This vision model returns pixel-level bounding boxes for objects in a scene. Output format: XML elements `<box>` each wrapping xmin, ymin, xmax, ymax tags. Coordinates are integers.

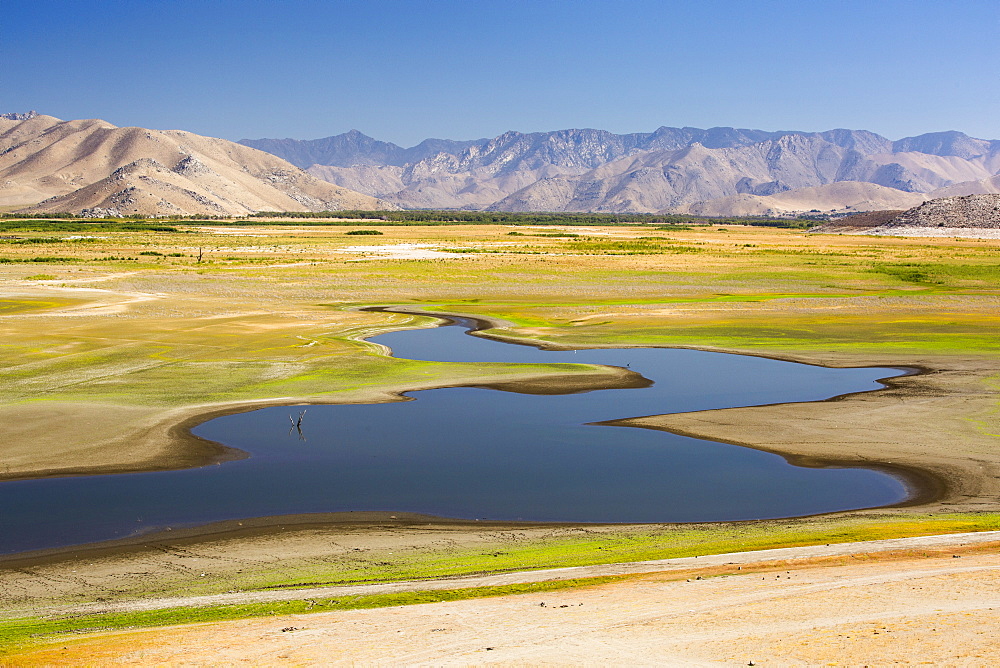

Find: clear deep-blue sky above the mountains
<box><xmin>0</xmin><ymin>0</ymin><xmax>1000</xmax><ymax>146</ymax></box>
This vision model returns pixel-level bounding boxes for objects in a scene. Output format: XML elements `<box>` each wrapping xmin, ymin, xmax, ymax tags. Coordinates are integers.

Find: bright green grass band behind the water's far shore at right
<box><xmin>434</xmin><ymin>298</ymin><xmax>1000</xmax><ymax>355</ymax></box>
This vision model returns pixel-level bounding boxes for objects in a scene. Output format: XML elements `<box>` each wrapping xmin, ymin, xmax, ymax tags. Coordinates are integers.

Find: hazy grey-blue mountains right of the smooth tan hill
<box><xmin>240</xmin><ymin>127</ymin><xmax>1000</xmax><ymax>216</ymax></box>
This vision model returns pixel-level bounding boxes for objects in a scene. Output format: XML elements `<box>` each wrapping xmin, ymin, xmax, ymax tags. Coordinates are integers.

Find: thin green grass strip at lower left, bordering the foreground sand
<box><xmin>0</xmin><ymin>576</ymin><xmax>616</xmax><ymax>656</ymax></box>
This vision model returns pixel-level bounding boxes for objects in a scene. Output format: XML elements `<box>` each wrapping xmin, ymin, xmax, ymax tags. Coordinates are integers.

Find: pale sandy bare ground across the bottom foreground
<box><xmin>7</xmin><ymin>536</ymin><xmax>1000</xmax><ymax>666</ymax></box>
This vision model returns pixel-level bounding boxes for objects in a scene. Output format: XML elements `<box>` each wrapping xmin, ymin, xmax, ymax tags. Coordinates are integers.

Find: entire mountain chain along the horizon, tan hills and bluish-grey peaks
<box><xmin>0</xmin><ymin>112</ymin><xmax>1000</xmax><ymax>216</ymax></box>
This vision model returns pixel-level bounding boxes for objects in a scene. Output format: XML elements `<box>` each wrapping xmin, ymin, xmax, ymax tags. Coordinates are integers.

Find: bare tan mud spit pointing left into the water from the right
<box><xmin>621</xmin><ymin>357</ymin><xmax>1000</xmax><ymax>512</ymax></box>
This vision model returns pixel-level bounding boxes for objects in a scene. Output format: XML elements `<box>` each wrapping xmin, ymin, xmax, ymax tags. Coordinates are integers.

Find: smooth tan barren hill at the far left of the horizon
<box><xmin>0</xmin><ymin>115</ymin><xmax>394</xmax><ymax>216</ymax></box>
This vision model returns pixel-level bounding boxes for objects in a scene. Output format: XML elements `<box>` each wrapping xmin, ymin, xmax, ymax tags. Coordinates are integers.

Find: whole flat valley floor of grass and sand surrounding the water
<box><xmin>0</xmin><ymin>220</ymin><xmax>1000</xmax><ymax>665</ymax></box>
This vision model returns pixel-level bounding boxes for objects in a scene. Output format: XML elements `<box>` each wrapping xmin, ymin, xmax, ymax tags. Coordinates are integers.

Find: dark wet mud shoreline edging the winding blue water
<box><xmin>0</xmin><ymin>307</ymin><xmax>984</xmax><ymax>564</ymax></box>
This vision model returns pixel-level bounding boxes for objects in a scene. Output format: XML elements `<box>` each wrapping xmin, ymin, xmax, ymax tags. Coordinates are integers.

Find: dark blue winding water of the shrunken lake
<box><xmin>0</xmin><ymin>319</ymin><xmax>908</xmax><ymax>553</ymax></box>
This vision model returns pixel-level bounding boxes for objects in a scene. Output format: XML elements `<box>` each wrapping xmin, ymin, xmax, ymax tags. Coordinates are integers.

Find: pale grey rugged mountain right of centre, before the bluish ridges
<box><xmin>490</xmin><ymin>135</ymin><xmax>960</xmax><ymax>215</ymax></box>
